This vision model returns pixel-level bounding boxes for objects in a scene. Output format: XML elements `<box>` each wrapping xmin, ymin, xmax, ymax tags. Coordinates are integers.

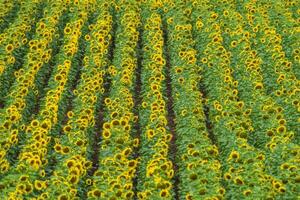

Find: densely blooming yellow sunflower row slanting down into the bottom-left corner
<box><xmin>0</xmin><ymin>1</ymin><xmax>94</xmax><ymax>198</ymax></box>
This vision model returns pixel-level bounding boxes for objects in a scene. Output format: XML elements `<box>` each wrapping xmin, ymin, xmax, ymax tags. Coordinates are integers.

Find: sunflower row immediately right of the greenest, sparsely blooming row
<box><xmin>191</xmin><ymin>1</ymin><xmax>288</xmax><ymax>198</ymax></box>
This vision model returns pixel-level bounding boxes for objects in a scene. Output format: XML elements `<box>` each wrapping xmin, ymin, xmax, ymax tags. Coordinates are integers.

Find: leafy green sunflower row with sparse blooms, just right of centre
<box><xmin>166</xmin><ymin>1</ymin><xmax>225</xmax><ymax>199</ymax></box>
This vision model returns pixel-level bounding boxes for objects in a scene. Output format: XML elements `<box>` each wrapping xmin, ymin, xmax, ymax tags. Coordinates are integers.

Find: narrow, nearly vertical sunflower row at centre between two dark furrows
<box><xmin>137</xmin><ymin>7</ymin><xmax>174</xmax><ymax>199</ymax></box>
